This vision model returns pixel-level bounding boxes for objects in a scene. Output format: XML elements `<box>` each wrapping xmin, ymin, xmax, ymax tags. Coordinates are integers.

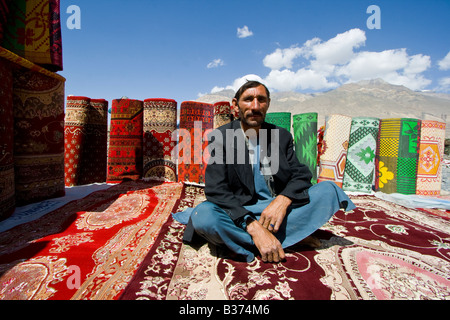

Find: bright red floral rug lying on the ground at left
<box><xmin>0</xmin><ymin>181</ymin><xmax>183</xmax><ymax>300</ymax></box>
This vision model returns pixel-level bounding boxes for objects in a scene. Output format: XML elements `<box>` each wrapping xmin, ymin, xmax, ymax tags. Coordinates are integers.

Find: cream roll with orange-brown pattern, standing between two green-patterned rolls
<box><xmin>317</xmin><ymin>114</ymin><xmax>352</xmax><ymax>188</ymax></box>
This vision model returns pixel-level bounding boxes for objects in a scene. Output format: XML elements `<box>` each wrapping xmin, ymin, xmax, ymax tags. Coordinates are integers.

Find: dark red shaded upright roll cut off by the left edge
<box><xmin>0</xmin><ymin>58</ymin><xmax>15</xmax><ymax>220</ymax></box>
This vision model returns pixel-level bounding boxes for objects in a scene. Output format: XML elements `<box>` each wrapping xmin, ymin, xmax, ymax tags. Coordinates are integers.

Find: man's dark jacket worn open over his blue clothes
<box><xmin>184</xmin><ymin>120</ymin><xmax>312</xmax><ymax>242</ymax></box>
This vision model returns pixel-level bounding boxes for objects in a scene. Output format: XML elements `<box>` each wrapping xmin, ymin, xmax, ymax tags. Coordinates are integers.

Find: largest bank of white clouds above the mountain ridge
<box><xmin>213</xmin><ymin>29</ymin><xmax>434</xmax><ymax>91</ymax></box>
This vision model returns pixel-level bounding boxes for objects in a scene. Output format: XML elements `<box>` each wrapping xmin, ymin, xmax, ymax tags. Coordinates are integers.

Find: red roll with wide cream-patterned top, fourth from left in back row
<box><xmin>143</xmin><ymin>99</ymin><xmax>177</xmax><ymax>181</ymax></box>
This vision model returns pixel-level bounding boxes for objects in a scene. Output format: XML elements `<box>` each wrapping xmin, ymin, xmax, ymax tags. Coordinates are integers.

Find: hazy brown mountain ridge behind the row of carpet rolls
<box><xmin>197</xmin><ymin>79</ymin><xmax>450</xmax><ymax>138</ymax></box>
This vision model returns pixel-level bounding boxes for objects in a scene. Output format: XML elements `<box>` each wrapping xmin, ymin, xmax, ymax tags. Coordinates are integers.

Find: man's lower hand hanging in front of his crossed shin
<box><xmin>247</xmin><ymin>220</ymin><xmax>285</xmax><ymax>262</ymax></box>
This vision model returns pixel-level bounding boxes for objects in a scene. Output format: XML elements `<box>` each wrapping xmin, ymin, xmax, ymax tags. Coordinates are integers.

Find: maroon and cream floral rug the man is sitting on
<box><xmin>120</xmin><ymin>186</ymin><xmax>450</xmax><ymax>300</ymax></box>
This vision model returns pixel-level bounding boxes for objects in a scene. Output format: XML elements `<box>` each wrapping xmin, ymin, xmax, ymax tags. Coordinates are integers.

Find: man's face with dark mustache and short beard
<box><xmin>233</xmin><ymin>86</ymin><xmax>270</xmax><ymax>129</ymax></box>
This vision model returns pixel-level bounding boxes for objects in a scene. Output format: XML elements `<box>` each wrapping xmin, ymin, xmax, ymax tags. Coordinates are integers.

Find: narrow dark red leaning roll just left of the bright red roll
<box><xmin>78</xmin><ymin>99</ymin><xmax>108</xmax><ymax>185</ymax></box>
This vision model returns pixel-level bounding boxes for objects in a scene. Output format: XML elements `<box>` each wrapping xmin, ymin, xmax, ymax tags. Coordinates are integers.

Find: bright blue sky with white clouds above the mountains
<box><xmin>61</xmin><ymin>0</ymin><xmax>450</xmax><ymax>104</ymax></box>
